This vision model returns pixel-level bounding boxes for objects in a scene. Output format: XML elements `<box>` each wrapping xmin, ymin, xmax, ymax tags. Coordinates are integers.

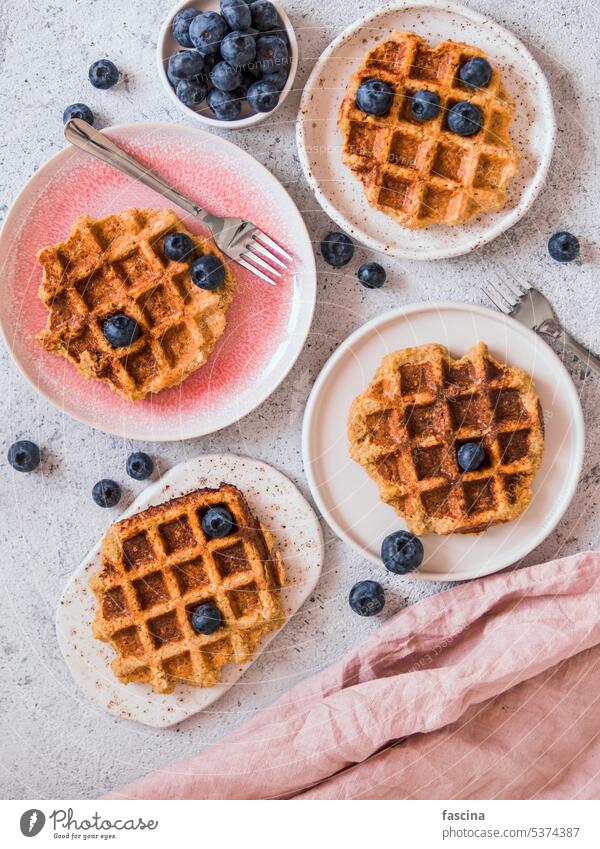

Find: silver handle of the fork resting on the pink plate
<box><xmin>65</xmin><ymin>118</ymin><xmax>213</xmax><ymax>226</ymax></box>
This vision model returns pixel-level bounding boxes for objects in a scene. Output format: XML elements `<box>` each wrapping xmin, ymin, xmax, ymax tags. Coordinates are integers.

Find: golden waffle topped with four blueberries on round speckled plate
<box><xmin>338</xmin><ymin>32</ymin><xmax>519</xmax><ymax>229</ymax></box>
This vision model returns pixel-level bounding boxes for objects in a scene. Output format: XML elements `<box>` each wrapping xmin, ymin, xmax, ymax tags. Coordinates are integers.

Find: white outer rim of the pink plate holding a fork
<box><xmin>0</xmin><ymin>121</ymin><xmax>317</xmax><ymax>442</ymax></box>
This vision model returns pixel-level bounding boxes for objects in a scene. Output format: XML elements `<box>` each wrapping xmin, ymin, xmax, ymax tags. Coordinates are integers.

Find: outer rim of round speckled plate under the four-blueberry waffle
<box><xmin>296</xmin><ymin>0</ymin><xmax>557</xmax><ymax>260</ymax></box>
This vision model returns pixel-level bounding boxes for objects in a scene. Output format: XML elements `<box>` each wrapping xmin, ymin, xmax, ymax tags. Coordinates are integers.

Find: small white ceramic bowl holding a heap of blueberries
<box><xmin>156</xmin><ymin>0</ymin><xmax>298</xmax><ymax>130</ymax></box>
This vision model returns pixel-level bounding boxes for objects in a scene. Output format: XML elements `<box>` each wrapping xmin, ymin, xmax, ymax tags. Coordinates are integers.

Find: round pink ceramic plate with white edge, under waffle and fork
<box><xmin>0</xmin><ymin>124</ymin><xmax>316</xmax><ymax>441</ymax></box>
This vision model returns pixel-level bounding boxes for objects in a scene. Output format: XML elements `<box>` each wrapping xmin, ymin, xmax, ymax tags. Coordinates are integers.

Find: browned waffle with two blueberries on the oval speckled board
<box><xmin>90</xmin><ymin>483</ymin><xmax>285</xmax><ymax>693</ymax></box>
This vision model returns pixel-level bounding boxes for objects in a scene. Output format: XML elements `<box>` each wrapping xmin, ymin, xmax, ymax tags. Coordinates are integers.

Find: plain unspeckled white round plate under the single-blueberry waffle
<box><xmin>302</xmin><ymin>303</ymin><xmax>584</xmax><ymax>581</ymax></box>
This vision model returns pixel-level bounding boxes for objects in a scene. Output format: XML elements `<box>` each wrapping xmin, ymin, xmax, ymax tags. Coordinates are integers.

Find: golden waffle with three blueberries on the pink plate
<box><xmin>38</xmin><ymin>209</ymin><xmax>235</xmax><ymax>401</ymax></box>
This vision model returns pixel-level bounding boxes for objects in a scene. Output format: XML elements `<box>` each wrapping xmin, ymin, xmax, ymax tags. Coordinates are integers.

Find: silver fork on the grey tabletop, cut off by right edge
<box><xmin>481</xmin><ymin>263</ymin><xmax>600</xmax><ymax>376</ymax></box>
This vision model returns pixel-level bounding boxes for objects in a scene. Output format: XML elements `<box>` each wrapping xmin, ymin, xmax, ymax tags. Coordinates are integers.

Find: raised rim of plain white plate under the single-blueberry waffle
<box><xmin>302</xmin><ymin>301</ymin><xmax>585</xmax><ymax>583</ymax></box>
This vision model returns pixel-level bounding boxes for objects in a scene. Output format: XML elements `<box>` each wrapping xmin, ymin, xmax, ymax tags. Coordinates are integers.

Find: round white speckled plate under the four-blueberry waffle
<box><xmin>297</xmin><ymin>0</ymin><xmax>556</xmax><ymax>260</ymax></box>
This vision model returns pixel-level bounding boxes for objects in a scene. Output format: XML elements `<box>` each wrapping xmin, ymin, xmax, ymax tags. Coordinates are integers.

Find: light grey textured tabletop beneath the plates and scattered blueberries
<box><xmin>0</xmin><ymin>0</ymin><xmax>600</xmax><ymax>798</ymax></box>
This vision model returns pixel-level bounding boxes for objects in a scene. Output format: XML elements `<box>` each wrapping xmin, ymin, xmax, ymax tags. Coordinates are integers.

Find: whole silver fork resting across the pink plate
<box><xmin>65</xmin><ymin>118</ymin><xmax>293</xmax><ymax>286</ymax></box>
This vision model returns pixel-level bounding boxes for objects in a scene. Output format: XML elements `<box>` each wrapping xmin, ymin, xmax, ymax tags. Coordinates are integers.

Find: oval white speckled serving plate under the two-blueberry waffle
<box><xmin>56</xmin><ymin>454</ymin><xmax>323</xmax><ymax>728</ymax></box>
